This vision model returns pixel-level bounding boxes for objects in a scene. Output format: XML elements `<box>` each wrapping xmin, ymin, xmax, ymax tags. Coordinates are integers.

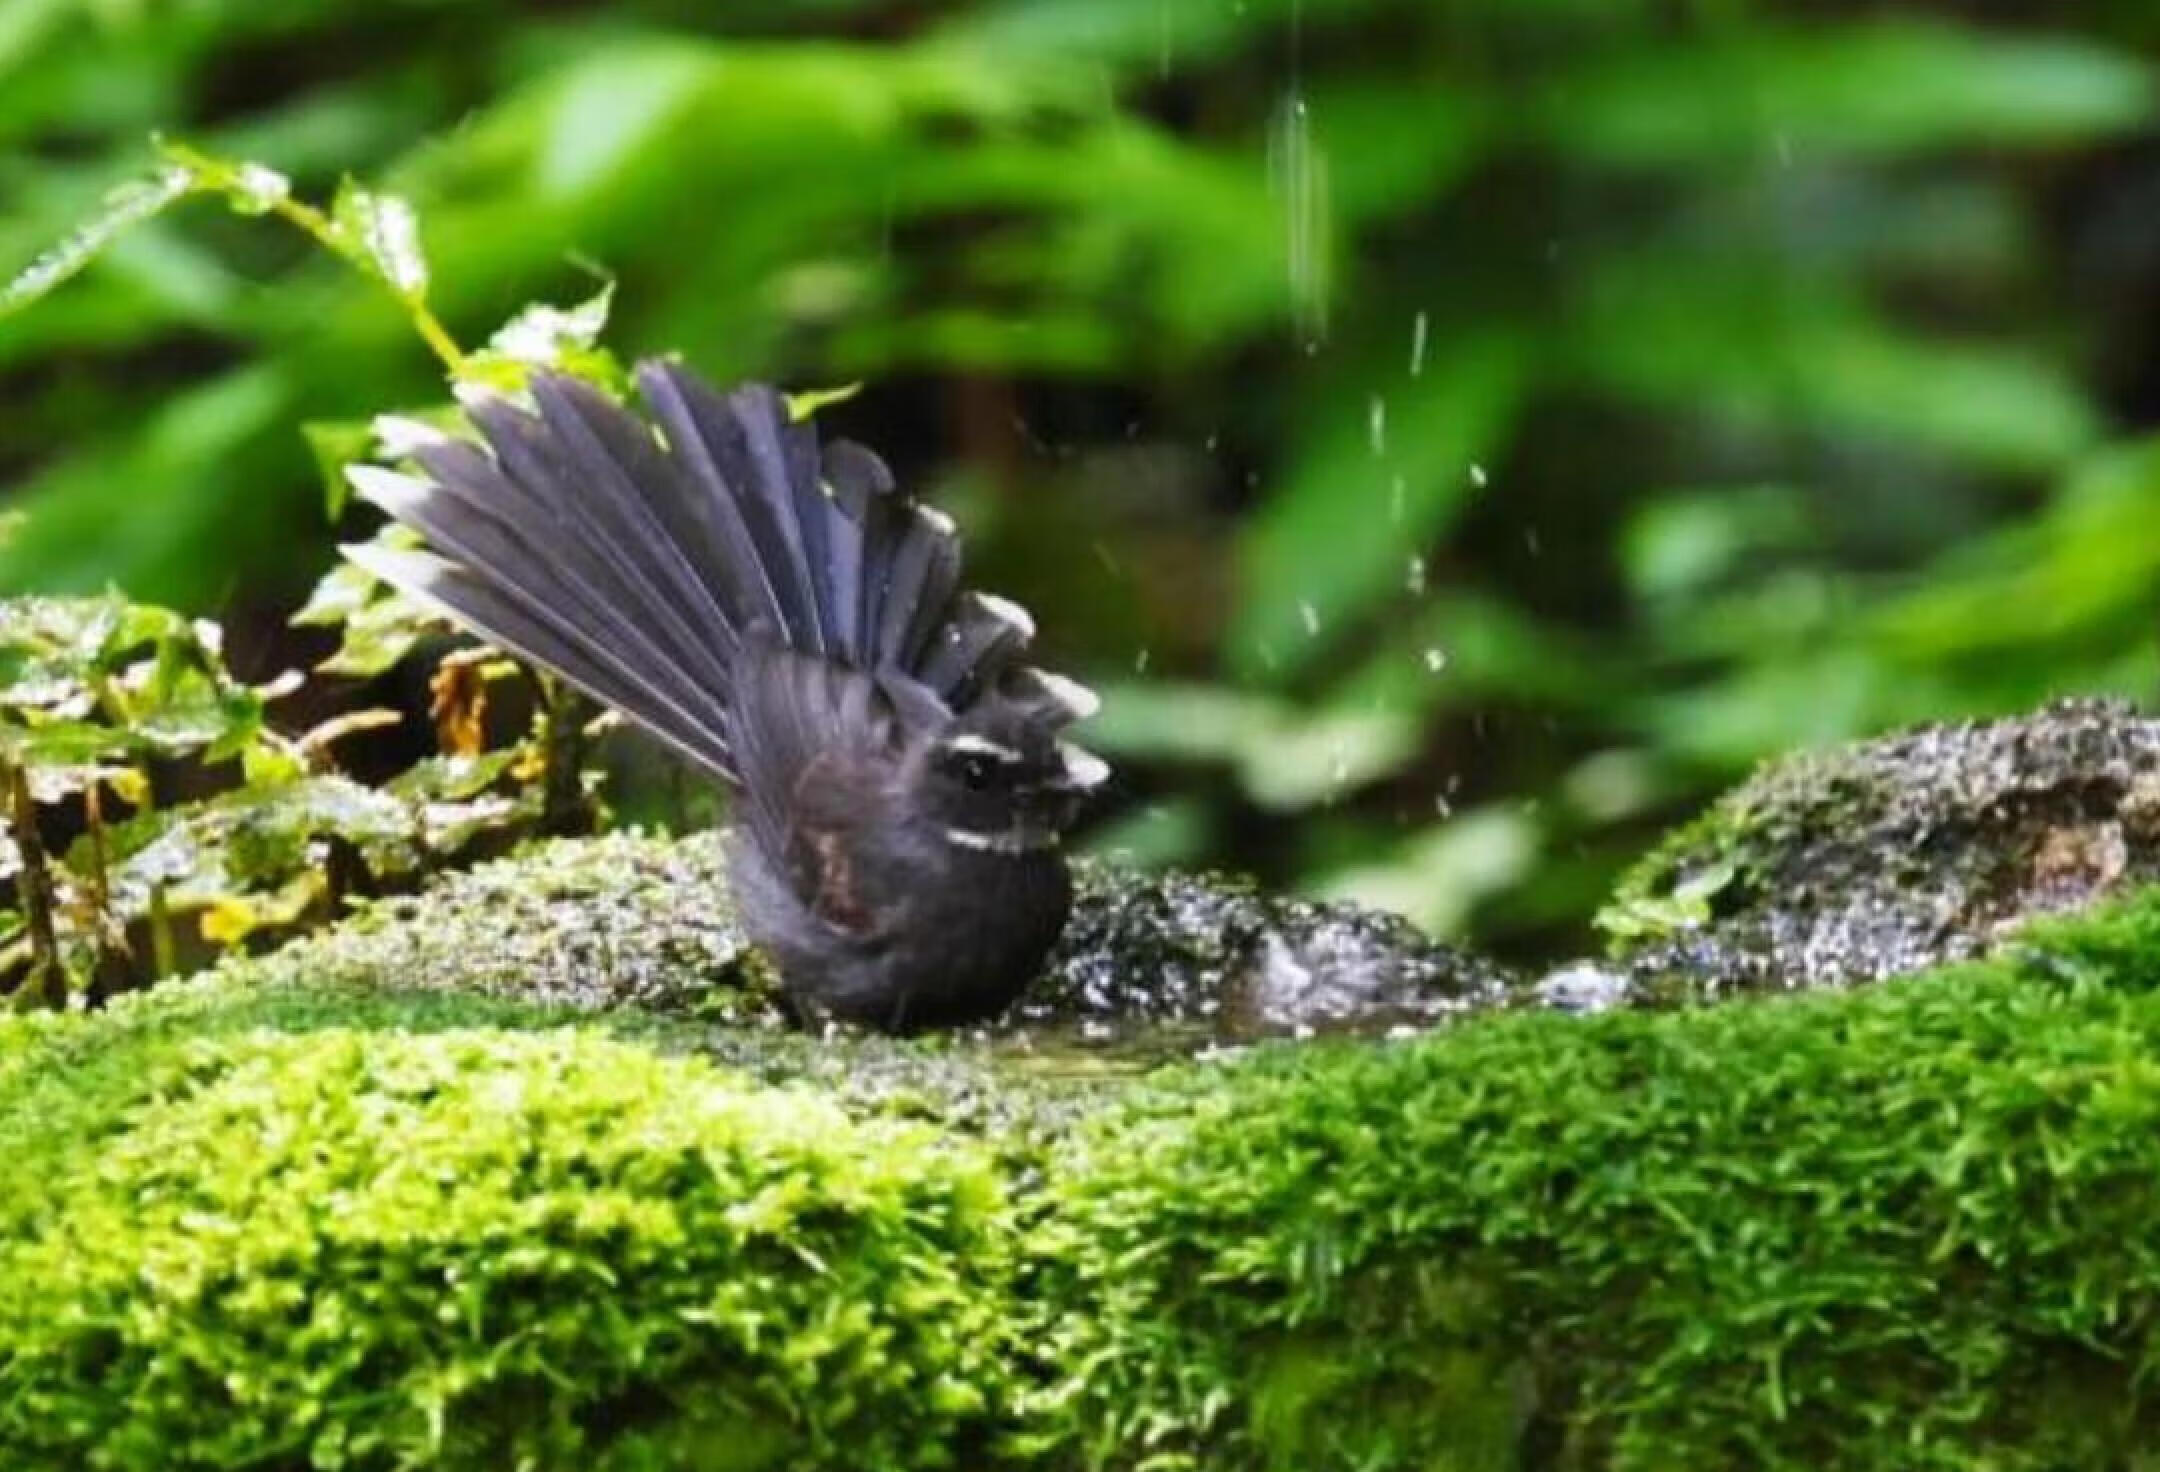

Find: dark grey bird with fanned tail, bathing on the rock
<box><xmin>341</xmin><ymin>359</ymin><xmax>1110</xmax><ymax>1033</ymax></box>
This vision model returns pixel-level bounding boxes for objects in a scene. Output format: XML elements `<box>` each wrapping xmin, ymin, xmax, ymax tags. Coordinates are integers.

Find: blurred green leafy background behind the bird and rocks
<box><xmin>0</xmin><ymin>0</ymin><xmax>2160</xmax><ymax>953</ymax></box>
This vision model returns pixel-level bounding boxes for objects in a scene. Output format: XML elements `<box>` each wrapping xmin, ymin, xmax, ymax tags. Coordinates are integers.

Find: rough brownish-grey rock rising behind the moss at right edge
<box><xmin>1598</xmin><ymin>700</ymin><xmax>2160</xmax><ymax>1005</ymax></box>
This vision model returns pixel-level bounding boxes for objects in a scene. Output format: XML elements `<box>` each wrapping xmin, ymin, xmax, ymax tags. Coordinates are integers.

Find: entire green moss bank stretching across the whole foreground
<box><xmin>12</xmin><ymin>891</ymin><xmax>2160</xmax><ymax>1472</ymax></box>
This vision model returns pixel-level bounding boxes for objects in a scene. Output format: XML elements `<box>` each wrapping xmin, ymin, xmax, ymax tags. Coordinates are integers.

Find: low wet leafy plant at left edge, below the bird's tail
<box><xmin>0</xmin><ymin>579</ymin><xmax>542</xmax><ymax>1003</ymax></box>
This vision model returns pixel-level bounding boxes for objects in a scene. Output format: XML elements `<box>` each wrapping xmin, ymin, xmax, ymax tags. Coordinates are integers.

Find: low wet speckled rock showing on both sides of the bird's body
<box><xmin>298</xmin><ymin>832</ymin><xmax>1510</xmax><ymax>1046</ymax></box>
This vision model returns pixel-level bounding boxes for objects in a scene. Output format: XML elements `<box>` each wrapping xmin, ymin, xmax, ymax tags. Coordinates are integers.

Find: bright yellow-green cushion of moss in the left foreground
<box><xmin>0</xmin><ymin>1002</ymin><xmax>1002</xmax><ymax>1470</ymax></box>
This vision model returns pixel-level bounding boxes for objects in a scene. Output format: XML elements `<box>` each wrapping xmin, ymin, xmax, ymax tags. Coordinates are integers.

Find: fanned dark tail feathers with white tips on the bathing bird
<box><xmin>348</xmin><ymin>361</ymin><xmax>1084</xmax><ymax>782</ymax></box>
